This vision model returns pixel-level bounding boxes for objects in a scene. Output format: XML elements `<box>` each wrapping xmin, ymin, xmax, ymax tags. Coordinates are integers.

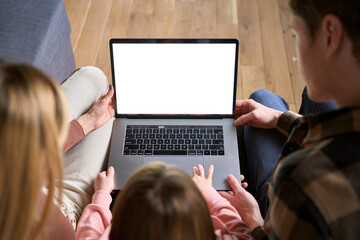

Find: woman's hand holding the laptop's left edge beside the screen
<box><xmin>76</xmin><ymin>85</ymin><xmax>115</xmax><ymax>135</ymax></box>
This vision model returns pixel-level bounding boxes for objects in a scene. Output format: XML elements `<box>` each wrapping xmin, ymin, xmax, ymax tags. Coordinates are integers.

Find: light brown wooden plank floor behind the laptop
<box><xmin>64</xmin><ymin>0</ymin><xmax>304</xmax><ymax>111</ymax></box>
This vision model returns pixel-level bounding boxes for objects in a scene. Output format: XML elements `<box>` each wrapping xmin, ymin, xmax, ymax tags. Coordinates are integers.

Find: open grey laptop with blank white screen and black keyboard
<box><xmin>108</xmin><ymin>39</ymin><xmax>240</xmax><ymax>190</ymax></box>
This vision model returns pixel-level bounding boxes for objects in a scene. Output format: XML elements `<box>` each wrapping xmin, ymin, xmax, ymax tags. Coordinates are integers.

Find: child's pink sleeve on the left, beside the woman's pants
<box><xmin>76</xmin><ymin>190</ymin><xmax>112</xmax><ymax>239</ymax></box>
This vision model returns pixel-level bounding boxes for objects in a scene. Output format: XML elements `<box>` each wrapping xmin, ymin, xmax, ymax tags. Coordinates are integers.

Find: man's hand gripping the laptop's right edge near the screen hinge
<box><xmin>235</xmin><ymin>99</ymin><xmax>283</xmax><ymax>129</ymax></box>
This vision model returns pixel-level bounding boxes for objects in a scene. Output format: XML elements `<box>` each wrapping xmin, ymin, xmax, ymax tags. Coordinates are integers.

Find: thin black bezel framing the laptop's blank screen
<box><xmin>109</xmin><ymin>38</ymin><xmax>239</xmax><ymax>119</ymax></box>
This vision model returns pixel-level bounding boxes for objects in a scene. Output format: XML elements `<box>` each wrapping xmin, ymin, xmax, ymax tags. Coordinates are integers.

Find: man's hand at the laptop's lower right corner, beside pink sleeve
<box><xmin>219</xmin><ymin>175</ymin><xmax>264</xmax><ymax>231</ymax></box>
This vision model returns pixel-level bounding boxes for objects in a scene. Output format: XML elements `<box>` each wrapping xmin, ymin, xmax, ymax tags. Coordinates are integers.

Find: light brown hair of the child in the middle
<box><xmin>110</xmin><ymin>162</ymin><xmax>215</xmax><ymax>240</ymax></box>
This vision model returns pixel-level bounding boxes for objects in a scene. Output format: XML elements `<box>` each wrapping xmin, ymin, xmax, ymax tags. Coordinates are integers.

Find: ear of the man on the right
<box><xmin>322</xmin><ymin>14</ymin><xmax>345</xmax><ymax>58</ymax></box>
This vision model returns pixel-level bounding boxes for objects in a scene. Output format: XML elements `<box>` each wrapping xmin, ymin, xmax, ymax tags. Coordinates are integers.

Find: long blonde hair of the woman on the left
<box><xmin>0</xmin><ymin>62</ymin><xmax>68</xmax><ymax>240</ymax></box>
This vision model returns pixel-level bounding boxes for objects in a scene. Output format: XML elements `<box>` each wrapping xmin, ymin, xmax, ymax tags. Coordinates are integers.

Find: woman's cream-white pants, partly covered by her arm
<box><xmin>60</xmin><ymin>67</ymin><xmax>114</xmax><ymax>228</ymax></box>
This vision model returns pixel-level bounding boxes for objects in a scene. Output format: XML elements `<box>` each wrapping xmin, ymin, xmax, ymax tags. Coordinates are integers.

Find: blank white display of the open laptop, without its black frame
<box><xmin>112</xmin><ymin>43</ymin><xmax>237</xmax><ymax>115</ymax></box>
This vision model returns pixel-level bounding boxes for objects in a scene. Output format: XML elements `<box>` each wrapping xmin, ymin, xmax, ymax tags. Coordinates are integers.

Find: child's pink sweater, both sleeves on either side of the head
<box><xmin>76</xmin><ymin>188</ymin><xmax>253</xmax><ymax>240</ymax></box>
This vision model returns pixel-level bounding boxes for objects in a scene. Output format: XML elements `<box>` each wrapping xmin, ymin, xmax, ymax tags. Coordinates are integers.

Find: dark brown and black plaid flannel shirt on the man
<box><xmin>253</xmin><ymin>107</ymin><xmax>360</xmax><ymax>239</ymax></box>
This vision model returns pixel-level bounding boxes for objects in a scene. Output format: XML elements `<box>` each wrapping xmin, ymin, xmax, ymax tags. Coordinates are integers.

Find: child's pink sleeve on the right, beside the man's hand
<box><xmin>203</xmin><ymin>188</ymin><xmax>253</xmax><ymax>239</ymax></box>
